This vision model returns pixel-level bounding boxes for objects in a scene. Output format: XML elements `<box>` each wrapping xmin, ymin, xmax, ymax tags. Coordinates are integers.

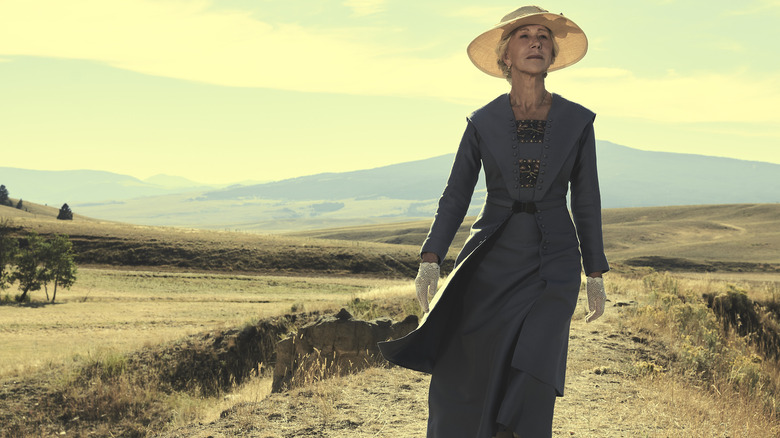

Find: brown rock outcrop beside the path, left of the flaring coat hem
<box><xmin>272</xmin><ymin>309</ymin><xmax>418</xmax><ymax>392</ymax></box>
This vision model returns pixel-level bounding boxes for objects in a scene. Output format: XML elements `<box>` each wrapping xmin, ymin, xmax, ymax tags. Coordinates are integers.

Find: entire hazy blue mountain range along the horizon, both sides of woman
<box><xmin>0</xmin><ymin>141</ymin><xmax>780</xmax><ymax>232</ymax></box>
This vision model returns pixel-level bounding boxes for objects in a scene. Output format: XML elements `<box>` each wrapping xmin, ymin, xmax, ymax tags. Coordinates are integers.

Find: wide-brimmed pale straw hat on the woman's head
<box><xmin>466</xmin><ymin>6</ymin><xmax>588</xmax><ymax>78</ymax></box>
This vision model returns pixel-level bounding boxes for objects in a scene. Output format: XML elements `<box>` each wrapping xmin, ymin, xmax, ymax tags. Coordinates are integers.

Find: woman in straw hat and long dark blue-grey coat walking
<box><xmin>380</xmin><ymin>6</ymin><xmax>609</xmax><ymax>438</ymax></box>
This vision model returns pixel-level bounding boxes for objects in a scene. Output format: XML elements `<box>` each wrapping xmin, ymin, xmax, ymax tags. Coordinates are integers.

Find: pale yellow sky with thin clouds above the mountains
<box><xmin>0</xmin><ymin>0</ymin><xmax>780</xmax><ymax>183</ymax></box>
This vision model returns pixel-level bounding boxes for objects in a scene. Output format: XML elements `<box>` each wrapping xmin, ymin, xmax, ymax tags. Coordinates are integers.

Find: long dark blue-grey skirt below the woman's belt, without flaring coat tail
<box><xmin>428</xmin><ymin>213</ymin><xmax>557</xmax><ymax>438</ymax></box>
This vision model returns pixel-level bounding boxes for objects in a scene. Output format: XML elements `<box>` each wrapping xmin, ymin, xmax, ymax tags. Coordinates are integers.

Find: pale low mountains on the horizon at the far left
<box><xmin>0</xmin><ymin>167</ymin><xmax>216</xmax><ymax>206</ymax></box>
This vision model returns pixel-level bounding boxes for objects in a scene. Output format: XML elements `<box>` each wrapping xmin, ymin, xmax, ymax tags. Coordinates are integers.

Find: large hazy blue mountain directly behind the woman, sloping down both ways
<box><xmin>198</xmin><ymin>141</ymin><xmax>780</xmax><ymax>208</ymax></box>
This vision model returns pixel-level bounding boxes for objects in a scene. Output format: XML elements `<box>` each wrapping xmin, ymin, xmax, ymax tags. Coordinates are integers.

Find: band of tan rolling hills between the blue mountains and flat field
<box><xmin>0</xmin><ymin>200</ymin><xmax>780</xmax><ymax>277</ymax></box>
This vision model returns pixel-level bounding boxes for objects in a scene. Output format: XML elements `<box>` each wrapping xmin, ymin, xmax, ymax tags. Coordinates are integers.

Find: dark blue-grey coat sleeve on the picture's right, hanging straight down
<box><xmin>571</xmin><ymin>123</ymin><xmax>609</xmax><ymax>274</ymax></box>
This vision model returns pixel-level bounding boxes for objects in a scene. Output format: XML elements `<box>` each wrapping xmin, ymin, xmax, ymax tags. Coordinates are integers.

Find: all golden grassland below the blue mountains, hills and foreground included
<box><xmin>0</xmin><ymin>204</ymin><xmax>780</xmax><ymax>438</ymax></box>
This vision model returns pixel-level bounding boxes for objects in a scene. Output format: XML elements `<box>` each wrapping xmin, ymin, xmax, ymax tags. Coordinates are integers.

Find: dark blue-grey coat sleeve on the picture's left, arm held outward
<box><xmin>421</xmin><ymin>121</ymin><xmax>482</xmax><ymax>261</ymax></box>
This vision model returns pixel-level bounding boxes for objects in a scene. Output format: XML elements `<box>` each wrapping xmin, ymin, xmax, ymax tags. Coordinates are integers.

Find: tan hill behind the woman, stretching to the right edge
<box><xmin>289</xmin><ymin>204</ymin><xmax>780</xmax><ymax>271</ymax></box>
